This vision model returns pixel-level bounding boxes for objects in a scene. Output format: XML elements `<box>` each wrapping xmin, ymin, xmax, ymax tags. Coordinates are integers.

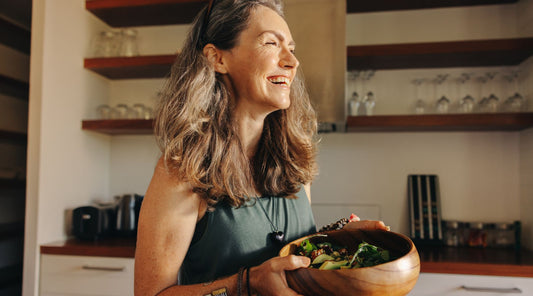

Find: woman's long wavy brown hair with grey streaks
<box><xmin>154</xmin><ymin>0</ymin><xmax>317</xmax><ymax>208</ymax></box>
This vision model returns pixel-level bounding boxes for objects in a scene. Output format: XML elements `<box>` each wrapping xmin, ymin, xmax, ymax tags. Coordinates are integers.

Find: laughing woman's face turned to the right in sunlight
<box><xmin>218</xmin><ymin>6</ymin><xmax>299</xmax><ymax>116</ymax></box>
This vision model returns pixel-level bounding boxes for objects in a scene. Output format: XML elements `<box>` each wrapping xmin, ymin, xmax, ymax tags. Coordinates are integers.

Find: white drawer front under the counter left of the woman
<box><xmin>40</xmin><ymin>254</ymin><xmax>134</xmax><ymax>296</ymax></box>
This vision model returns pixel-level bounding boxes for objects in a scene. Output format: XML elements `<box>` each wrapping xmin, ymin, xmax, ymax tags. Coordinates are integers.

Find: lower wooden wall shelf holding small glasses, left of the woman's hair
<box><xmin>81</xmin><ymin>119</ymin><xmax>154</xmax><ymax>135</ymax></box>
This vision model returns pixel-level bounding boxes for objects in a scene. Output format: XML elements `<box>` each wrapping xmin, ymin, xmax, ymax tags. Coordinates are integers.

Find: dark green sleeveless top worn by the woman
<box><xmin>179</xmin><ymin>186</ymin><xmax>316</xmax><ymax>285</ymax></box>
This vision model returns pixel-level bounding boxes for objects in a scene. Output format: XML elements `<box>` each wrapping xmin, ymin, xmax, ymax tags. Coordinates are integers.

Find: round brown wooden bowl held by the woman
<box><xmin>279</xmin><ymin>229</ymin><xmax>420</xmax><ymax>296</ymax></box>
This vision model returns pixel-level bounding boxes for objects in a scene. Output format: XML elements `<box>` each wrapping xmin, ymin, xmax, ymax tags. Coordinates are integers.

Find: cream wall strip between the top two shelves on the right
<box><xmin>346</xmin><ymin>4</ymin><xmax>518</xmax><ymax>45</ymax></box>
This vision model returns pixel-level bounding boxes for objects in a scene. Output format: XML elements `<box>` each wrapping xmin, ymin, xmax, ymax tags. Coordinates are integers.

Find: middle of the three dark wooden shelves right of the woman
<box><xmin>347</xmin><ymin>38</ymin><xmax>533</xmax><ymax>70</ymax></box>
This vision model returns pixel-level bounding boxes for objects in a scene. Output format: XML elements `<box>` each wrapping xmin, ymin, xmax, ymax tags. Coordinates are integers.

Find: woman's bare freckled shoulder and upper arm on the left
<box><xmin>135</xmin><ymin>160</ymin><xmax>202</xmax><ymax>295</ymax></box>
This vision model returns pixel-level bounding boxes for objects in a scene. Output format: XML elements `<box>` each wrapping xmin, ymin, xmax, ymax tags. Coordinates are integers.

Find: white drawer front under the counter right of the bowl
<box><xmin>409</xmin><ymin>273</ymin><xmax>533</xmax><ymax>296</ymax></box>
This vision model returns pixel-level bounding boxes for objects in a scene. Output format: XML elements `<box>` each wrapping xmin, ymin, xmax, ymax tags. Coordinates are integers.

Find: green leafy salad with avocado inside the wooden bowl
<box><xmin>295</xmin><ymin>234</ymin><xmax>393</xmax><ymax>270</ymax></box>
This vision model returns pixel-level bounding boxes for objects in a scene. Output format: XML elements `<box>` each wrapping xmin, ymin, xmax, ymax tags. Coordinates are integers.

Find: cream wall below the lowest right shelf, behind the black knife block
<box><xmin>312</xmin><ymin>132</ymin><xmax>520</xmax><ymax>234</ymax></box>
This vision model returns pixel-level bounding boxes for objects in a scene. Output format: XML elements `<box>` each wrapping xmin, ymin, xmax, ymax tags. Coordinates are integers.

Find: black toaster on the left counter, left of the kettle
<box><xmin>72</xmin><ymin>205</ymin><xmax>116</xmax><ymax>240</ymax></box>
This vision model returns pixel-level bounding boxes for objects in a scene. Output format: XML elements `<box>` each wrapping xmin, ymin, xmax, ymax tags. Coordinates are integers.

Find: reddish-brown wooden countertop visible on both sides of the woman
<box><xmin>41</xmin><ymin>238</ymin><xmax>533</xmax><ymax>277</ymax></box>
